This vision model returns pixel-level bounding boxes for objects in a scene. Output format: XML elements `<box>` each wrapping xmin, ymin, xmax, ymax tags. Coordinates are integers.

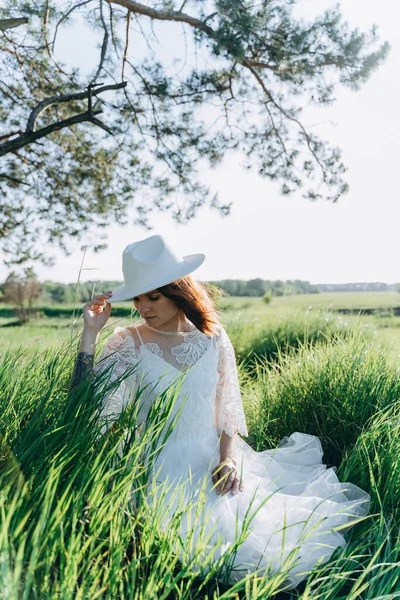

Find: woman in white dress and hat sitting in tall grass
<box><xmin>73</xmin><ymin>236</ymin><xmax>369</xmax><ymax>588</ymax></box>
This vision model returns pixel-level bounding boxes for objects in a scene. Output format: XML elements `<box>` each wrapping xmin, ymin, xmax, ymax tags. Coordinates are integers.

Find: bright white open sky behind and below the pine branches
<box><xmin>0</xmin><ymin>0</ymin><xmax>400</xmax><ymax>283</ymax></box>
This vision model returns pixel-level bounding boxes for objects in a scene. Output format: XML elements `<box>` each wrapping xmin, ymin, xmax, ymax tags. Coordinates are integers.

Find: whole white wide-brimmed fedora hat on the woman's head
<box><xmin>108</xmin><ymin>235</ymin><xmax>205</xmax><ymax>302</ymax></box>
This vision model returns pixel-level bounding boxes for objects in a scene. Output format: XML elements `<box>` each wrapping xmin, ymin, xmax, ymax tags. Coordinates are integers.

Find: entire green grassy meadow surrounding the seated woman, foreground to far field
<box><xmin>0</xmin><ymin>293</ymin><xmax>400</xmax><ymax>600</ymax></box>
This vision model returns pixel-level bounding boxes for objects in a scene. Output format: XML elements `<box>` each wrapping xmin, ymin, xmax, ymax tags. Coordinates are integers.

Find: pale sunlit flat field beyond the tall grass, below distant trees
<box><xmin>0</xmin><ymin>292</ymin><xmax>400</xmax><ymax>350</ymax></box>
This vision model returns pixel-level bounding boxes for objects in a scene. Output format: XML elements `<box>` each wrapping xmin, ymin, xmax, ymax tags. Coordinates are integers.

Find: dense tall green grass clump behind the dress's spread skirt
<box><xmin>245</xmin><ymin>331</ymin><xmax>400</xmax><ymax>465</ymax></box>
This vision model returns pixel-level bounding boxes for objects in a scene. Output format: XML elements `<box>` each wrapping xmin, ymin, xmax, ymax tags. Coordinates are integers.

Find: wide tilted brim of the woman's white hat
<box><xmin>107</xmin><ymin>254</ymin><xmax>205</xmax><ymax>303</ymax></box>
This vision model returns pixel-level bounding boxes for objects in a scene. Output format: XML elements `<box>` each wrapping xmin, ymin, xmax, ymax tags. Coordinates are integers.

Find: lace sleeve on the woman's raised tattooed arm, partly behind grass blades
<box><xmin>93</xmin><ymin>327</ymin><xmax>138</xmax><ymax>433</ymax></box>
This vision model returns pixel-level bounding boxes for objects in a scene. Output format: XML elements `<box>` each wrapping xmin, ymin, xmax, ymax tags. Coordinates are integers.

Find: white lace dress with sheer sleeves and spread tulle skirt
<box><xmin>94</xmin><ymin>325</ymin><xmax>369</xmax><ymax>588</ymax></box>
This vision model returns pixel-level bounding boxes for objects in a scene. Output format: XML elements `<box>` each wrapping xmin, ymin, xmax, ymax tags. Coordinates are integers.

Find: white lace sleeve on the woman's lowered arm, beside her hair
<box><xmin>215</xmin><ymin>327</ymin><xmax>248</xmax><ymax>437</ymax></box>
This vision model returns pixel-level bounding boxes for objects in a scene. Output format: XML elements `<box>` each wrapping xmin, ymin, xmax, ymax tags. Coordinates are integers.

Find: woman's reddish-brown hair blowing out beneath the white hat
<box><xmin>153</xmin><ymin>275</ymin><xmax>224</xmax><ymax>335</ymax></box>
